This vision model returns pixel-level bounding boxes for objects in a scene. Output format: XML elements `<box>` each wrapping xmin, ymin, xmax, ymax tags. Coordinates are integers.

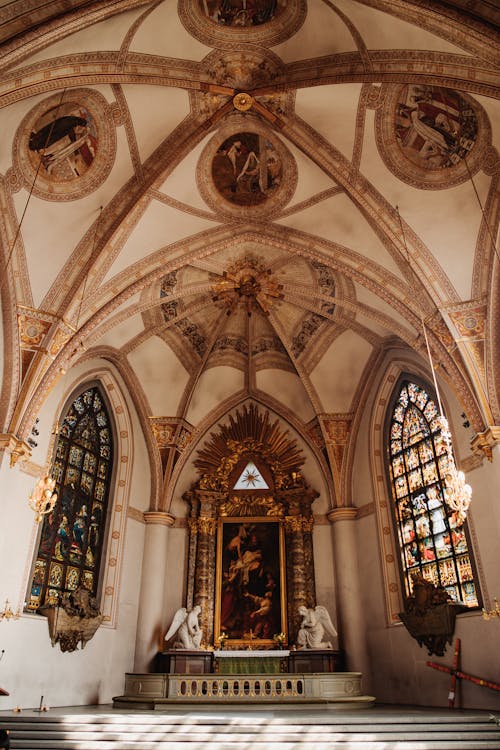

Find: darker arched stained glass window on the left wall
<box><xmin>27</xmin><ymin>386</ymin><xmax>113</xmax><ymax>610</ymax></box>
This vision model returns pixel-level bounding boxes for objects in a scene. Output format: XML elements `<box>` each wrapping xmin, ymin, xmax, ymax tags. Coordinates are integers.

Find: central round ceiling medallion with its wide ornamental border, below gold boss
<box><xmin>198</xmin><ymin>116</ymin><xmax>297</xmax><ymax>219</ymax></box>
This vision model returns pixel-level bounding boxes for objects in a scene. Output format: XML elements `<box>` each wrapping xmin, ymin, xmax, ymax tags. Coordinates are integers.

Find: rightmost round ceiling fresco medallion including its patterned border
<box><xmin>375</xmin><ymin>84</ymin><xmax>490</xmax><ymax>188</ymax></box>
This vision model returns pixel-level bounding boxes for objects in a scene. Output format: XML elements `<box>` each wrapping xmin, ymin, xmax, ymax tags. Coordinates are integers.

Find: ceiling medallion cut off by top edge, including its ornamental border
<box><xmin>179</xmin><ymin>0</ymin><xmax>307</xmax><ymax>48</ymax></box>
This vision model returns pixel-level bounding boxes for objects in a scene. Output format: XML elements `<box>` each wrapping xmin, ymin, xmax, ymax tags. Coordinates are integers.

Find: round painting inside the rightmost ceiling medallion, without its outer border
<box><xmin>395</xmin><ymin>84</ymin><xmax>478</xmax><ymax>170</ymax></box>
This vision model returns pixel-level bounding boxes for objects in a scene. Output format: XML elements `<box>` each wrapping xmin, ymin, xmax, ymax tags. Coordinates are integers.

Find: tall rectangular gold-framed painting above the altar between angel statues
<box><xmin>215</xmin><ymin>518</ymin><xmax>286</xmax><ymax>648</ymax></box>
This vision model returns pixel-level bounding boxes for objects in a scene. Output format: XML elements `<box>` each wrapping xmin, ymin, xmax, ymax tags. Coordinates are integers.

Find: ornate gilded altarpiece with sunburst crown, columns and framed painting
<box><xmin>183</xmin><ymin>404</ymin><xmax>318</xmax><ymax>648</ymax></box>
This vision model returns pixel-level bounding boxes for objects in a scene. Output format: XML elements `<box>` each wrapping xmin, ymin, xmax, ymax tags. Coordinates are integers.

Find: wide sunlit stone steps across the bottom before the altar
<box><xmin>0</xmin><ymin>706</ymin><xmax>500</xmax><ymax>750</ymax></box>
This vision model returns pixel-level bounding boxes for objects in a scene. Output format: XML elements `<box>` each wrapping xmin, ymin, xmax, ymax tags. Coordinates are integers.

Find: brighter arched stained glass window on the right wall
<box><xmin>389</xmin><ymin>381</ymin><xmax>479</xmax><ymax>607</ymax></box>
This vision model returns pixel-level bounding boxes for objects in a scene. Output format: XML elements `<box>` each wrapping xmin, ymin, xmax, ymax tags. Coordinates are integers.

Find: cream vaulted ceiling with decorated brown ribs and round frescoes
<box><xmin>0</xmin><ymin>0</ymin><xmax>500</xmax><ymax>506</ymax></box>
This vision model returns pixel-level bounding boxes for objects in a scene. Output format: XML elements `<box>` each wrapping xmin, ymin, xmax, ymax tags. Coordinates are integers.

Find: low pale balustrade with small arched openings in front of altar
<box><xmin>113</xmin><ymin>672</ymin><xmax>375</xmax><ymax>711</ymax></box>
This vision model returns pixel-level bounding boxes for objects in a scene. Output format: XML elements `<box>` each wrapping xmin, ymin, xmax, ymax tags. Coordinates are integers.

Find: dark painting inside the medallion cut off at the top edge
<box><xmin>199</xmin><ymin>0</ymin><xmax>287</xmax><ymax>28</ymax></box>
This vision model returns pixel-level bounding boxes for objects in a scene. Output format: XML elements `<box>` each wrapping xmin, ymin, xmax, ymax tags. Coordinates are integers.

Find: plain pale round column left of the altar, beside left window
<box><xmin>134</xmin><ymin>511</ymin><xmax>175</xmax><ymax>672</ymax></box>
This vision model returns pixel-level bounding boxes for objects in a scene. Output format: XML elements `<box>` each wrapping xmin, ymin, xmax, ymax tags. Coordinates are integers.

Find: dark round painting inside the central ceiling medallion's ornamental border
<box><xmin>212</xmin><ymin>132</ymin><xmax>283</xmax><ymax>206</ymax></box>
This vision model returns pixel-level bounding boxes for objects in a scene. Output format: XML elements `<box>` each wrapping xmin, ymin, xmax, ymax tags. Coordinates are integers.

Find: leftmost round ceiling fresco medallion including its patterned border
<box><xmin>14</xmin><ymin>89</ymin><xmax>116</xmax><ymax>200</ymax></box>
